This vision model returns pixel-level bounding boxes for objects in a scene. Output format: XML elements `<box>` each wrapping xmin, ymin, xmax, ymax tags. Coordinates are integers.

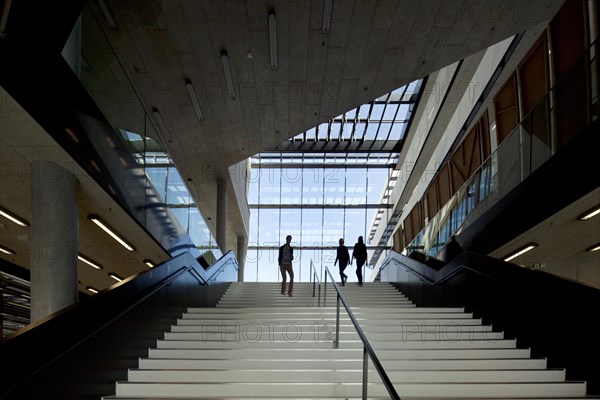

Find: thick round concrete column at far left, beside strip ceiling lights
<box><xmin>30</xmin><ymin>161</ymin><xmax>78</xmax><ymax>322</ymax></box>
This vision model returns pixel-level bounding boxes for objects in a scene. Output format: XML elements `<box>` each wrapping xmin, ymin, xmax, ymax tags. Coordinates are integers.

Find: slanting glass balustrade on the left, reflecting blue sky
<box><xmin>71</xmin><ymin>4</ymin><xmax>222</xmax><ymax>258</ymax></box>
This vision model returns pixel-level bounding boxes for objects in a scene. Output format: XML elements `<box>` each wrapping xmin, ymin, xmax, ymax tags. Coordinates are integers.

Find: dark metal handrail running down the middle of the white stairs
<box><xmin>319</xmin><ymin>267</ymin><xmax>400</xmax><ymax>400</ymax></box>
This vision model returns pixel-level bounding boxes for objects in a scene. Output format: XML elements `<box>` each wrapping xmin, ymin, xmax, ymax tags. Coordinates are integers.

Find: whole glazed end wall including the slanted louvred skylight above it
<box><xmin>244</xmin><ymin>80</ymin><xmax>423</xmax><ymax>282</ymax></box>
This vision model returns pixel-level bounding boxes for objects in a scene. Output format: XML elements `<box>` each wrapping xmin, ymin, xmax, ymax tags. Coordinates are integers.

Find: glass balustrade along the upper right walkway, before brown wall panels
<box><xmin>403</xmin><ymin>38</ymin><xmax>600</xmax><ymax>257</ymax></box>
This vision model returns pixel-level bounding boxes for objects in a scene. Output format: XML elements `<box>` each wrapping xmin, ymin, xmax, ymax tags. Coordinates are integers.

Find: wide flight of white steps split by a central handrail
<box><xmin>103</xmin><ymin>283</ymin><xmax>586</xmax><ymax>400</ymax></box>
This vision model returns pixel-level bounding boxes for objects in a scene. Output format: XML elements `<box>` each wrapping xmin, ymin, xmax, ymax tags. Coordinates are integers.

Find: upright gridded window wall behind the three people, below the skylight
<box><xmin>244</xmin><ymin>158</ymin><xmax>396</xmax><ymax>282</ymax></box>
